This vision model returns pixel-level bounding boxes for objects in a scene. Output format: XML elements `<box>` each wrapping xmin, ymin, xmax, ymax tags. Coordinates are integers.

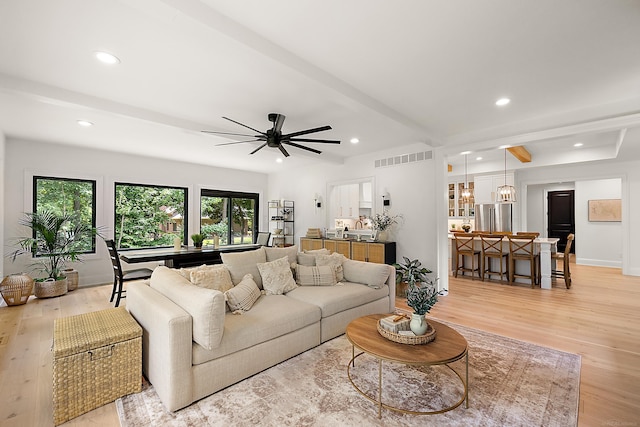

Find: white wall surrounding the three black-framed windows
<box><xmin>1</xmin><ymin>138</ymin><xmax>268</xmax><ymax>286</ymax></box>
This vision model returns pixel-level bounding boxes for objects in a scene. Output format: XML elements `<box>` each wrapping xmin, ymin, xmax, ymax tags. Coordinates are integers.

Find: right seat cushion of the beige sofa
<box><xmin>286</xmin><ymin>282</ymin><xmax>389</xmax><ymax>320</ymax></box>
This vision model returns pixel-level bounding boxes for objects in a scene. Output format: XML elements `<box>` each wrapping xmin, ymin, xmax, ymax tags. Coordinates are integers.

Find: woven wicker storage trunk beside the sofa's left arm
<box><xmin>52</xmin><ymin>307</ymin><xmax>142</xmax><ymax>425</ymax></box>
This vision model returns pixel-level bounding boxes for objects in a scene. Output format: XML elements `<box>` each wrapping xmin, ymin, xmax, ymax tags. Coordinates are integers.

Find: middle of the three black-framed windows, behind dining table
<box><xmin>113</xmin><ymin>182</ymin><xmax>188</xmax><ymax>249</ymax></box>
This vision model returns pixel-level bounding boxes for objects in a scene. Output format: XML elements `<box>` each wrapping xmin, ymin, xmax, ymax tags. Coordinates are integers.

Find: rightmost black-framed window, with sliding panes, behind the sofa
<box><xmin>200</xmin><ymin>190</ymin><xmax>259</xmax><ymax>245</ymax></box>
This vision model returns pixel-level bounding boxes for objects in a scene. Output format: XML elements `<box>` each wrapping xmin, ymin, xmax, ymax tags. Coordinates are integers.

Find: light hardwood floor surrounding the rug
<box><xmin>0</xmin><ymin>266</ymin><xmax>640</xmax><ymax>427</ymax></box>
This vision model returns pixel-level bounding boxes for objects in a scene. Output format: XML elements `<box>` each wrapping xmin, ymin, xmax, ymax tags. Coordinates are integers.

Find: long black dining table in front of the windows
<box><xmin>119</xmin><ymin>244</ymin><xmax>260</xmax><ymax>268</ymax></box>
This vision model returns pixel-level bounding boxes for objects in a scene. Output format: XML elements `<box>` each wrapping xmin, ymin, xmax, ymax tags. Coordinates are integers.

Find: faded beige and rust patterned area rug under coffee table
<box><xmin>116</xmin><ymin>325</ymin><xmax>580</xmax><ymax>427</ymax></box>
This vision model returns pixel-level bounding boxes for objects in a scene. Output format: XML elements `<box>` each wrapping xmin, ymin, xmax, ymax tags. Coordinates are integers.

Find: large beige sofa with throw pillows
<box><xmin>127</xmin><ymin>246</ymin><xmax>395</xmax><ymax>411</ymax></box>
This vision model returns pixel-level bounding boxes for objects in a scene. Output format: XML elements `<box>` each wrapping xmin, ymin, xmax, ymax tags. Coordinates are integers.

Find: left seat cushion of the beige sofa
<box><xmin>192</xmin><ymin>296</ymin><xmax>320</xmax><ymax>365</ymax></box>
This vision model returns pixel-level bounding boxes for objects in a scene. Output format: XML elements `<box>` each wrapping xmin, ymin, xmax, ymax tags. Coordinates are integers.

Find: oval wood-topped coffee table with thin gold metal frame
<box><xmin>347</xmin><ymin>314</ymin><xmax>469</xmax><ymax>418</ymax></box>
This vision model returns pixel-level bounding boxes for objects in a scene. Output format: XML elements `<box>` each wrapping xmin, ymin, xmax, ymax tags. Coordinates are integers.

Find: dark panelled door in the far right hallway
<box><xmin>547</xmin><ymin>190</ymin><xmax>576</xmax><ymax>253</ymax></box>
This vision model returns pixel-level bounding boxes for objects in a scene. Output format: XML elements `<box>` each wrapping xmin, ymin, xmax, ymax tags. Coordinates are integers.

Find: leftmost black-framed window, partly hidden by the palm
<box><xmin>33</xmin><ymin>176</ymin><xmax>96</xmax><ymax>253</ymax></box>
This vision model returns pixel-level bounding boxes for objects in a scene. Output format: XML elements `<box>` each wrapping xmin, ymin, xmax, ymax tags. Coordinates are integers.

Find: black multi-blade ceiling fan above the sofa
<box><xmin>202</xmin><ymin>113</ymin><xmax>340</xmax><ymax>157</ymax></box>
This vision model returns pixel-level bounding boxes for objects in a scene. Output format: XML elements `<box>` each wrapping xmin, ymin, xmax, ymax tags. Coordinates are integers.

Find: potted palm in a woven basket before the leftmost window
<box><xmin>10</xmin><ymin>210</ymin><xmax>97</xmax><ymax>298</ymax></box>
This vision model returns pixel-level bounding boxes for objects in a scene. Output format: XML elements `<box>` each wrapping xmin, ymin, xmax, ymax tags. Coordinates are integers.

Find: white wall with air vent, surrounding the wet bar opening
<box><xmin>268</xmin><ymin>144</ymin><xmax>447</xmax><ymax>276</ymax></box>
